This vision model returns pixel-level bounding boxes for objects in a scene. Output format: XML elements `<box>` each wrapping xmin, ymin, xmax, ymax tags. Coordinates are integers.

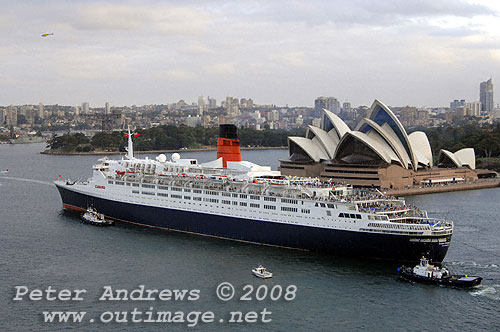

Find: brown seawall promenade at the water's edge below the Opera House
<box><xmin>384</xmin><ymin>178</ymin><xmax>500</xmax><ymax>197</ymax></box>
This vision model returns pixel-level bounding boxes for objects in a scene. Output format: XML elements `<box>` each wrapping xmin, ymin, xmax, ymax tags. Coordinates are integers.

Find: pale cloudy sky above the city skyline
<box><xmin>0</xmin><ymin>0</ymin><xmax>500</xmax><ymax>107</ymax></box>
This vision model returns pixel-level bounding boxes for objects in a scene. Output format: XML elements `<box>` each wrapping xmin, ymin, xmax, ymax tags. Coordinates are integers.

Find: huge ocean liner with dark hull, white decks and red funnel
<box><xmin>55</xmin><ymin>125</ymin><xmax>453</xmax><ymax>263</ymax></box>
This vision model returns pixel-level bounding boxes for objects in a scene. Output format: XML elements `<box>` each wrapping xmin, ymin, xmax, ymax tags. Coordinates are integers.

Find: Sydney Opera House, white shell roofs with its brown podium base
<box><xmin>280</xmin><ymin>100</ymin><xmax>478</xmax><ymax>189</ymax></box>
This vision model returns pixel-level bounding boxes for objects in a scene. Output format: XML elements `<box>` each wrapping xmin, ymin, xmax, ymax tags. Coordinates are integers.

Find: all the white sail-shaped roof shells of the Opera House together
<box><xmin>289</xmin><ymin>100</ymin><xmax>476</xmax><ymax>171</ymax></box>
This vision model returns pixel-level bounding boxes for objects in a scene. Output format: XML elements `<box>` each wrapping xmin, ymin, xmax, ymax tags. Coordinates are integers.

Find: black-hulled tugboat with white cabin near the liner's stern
<box><xmin>397</xmin><ymin>256</ymin><xmax>483</xmax><ymax>288</ymax></box>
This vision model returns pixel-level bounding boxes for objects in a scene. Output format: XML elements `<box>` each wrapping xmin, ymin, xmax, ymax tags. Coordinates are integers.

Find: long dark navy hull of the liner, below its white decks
<box><xmin>56</xmin><ymin>185</ymin><xmax>451</xmax><ymax>263</ymax></box>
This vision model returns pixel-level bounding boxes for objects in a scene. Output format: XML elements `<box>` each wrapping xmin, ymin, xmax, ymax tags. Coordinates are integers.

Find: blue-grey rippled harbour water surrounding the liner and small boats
<box><xmin>0</xmin><ymin>144</ymin><xmax>500</xmax><ymax>331</ymax></box>
